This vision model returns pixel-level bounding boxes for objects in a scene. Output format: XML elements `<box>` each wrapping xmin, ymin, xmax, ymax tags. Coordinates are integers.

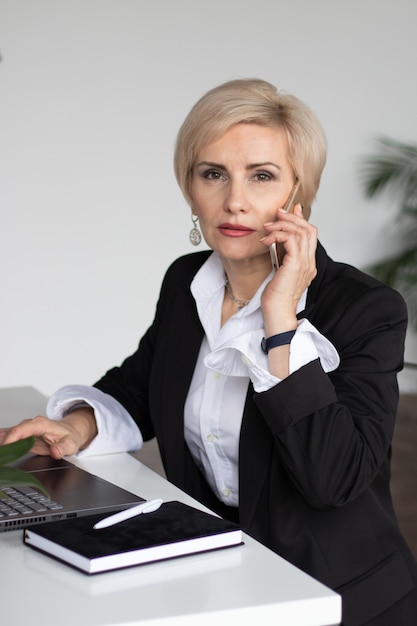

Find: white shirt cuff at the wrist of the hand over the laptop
<box><xmin>46</xmin><ymin>385</ymin><xmax>143</xmax><ymax>458</ymax></box>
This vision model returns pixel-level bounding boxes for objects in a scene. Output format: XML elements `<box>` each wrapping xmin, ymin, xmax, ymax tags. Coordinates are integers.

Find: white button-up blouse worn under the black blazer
<box><xmin>184</xmin><ymin>253</ymin><xmax>339</xmax><ymax>506</ymax></box>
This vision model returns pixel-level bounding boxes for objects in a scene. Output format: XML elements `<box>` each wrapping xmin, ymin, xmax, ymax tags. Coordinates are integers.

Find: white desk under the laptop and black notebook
<box><xmin>0</xmin><ymin>387</ymin><xmax>341</xmax><ymax>626</ymax></box>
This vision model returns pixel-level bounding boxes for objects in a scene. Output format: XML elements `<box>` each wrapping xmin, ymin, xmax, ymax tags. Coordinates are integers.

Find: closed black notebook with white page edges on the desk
<box><xmin>24</xmin><ymin>502</ymin><xmax>242</xmax><ymax>574</ymax></box>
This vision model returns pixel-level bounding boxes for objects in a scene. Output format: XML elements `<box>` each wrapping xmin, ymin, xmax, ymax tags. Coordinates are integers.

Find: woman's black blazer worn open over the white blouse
<box><xmin>96</xmin><ymin>244</ymin><xmax>417</xmax><ymax>625</ymax></box>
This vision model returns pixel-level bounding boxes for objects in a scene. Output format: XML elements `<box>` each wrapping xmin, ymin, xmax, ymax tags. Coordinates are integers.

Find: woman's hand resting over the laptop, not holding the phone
<box><xmin>0</xmin><ymin>407</ymin><xmax>97</xmax><ymax>459</ymax></box>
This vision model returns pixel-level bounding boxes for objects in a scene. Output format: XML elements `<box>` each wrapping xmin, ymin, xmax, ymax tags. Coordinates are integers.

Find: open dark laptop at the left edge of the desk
<box><xmin>0</xmin><ymin>388</ymin><xmax>144</xmax><ymax>532</ymax></box>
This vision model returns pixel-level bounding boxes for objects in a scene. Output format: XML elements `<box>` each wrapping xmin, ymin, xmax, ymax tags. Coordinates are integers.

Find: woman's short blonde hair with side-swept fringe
<box><xmin>174</xmin><ymin>79</ymin><xmax>327</xmax><ymax>219</ymax></box>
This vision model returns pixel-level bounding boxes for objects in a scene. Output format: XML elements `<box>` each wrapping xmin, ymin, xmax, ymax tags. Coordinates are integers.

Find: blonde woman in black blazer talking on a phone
<box><xmin>2</xmin><ymin>80</ymin><xmax>417</xmax><ymax>626</ymax></box>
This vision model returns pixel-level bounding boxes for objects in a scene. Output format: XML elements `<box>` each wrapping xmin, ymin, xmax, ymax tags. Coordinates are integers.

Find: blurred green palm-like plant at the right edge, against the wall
<box><xmin>361</xmin><ymin>137</ymin><xmax>417</xmax><ymax>330</ymax></box>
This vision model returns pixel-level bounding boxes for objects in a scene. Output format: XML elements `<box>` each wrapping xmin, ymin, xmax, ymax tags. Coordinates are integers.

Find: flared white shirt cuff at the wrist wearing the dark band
<box><xmin>204</xmin><ymin>319</ymin><xmax>340</xmax><ymax>393</ymax></box>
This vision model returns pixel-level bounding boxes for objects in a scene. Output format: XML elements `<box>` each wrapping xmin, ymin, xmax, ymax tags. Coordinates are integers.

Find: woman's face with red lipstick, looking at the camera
<box><xmin>190</xmin><ymin>124</ymin><xmax>295</xmax><ymax>263</ymax></box>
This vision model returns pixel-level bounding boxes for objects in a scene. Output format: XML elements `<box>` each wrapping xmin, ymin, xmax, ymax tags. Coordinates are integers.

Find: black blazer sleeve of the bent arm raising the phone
<box><xmin>255</xmin><ymin>283</ymin><xmax>407</xmax><ymax>510</ymax></box>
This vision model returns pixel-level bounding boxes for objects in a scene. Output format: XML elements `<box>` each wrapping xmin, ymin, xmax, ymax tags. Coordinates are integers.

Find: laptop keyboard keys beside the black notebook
<box><xmin>0</xmin><ymin>485</ymin><xmax>63</xmax><ymax>520</ymax></box>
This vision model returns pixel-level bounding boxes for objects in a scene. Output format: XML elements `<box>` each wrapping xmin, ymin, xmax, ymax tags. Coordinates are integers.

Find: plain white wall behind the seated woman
<box><xmin>0</xmin><ymin>0</ymin><xmax>417</xmax><ymax>394</ymax></box>
